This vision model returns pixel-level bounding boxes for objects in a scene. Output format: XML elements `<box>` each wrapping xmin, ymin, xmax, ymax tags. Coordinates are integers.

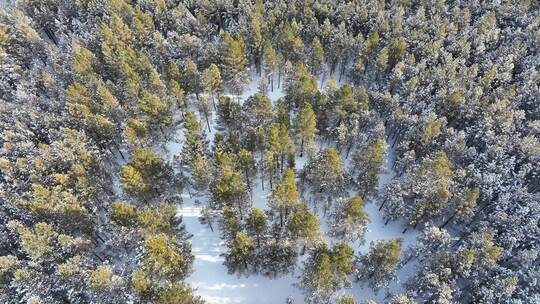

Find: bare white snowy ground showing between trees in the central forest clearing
<box><xmin>162</xmin><ymin>75</ymin><xmax>418</xmax><ymax>304</ymax></box>
